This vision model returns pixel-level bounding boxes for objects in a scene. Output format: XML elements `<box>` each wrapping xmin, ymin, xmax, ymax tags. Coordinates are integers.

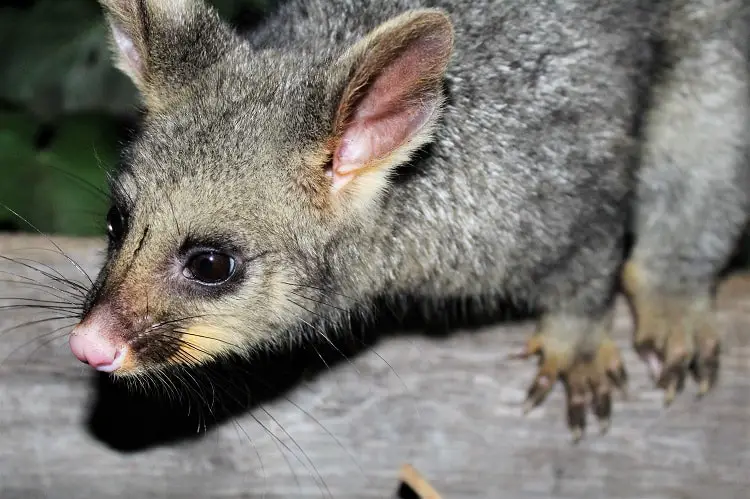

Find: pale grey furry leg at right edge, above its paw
<box><xmin>633</xmin><ymin>0</ymin><xmax>750</xmax><ymax>293</ymax></box>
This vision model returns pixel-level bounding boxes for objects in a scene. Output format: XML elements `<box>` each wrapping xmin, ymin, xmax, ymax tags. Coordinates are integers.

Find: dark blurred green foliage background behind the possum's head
<box><xmin>0</xmin><ymin>0</ymin><xmax>273</xmax><ymax>236</ymax></box>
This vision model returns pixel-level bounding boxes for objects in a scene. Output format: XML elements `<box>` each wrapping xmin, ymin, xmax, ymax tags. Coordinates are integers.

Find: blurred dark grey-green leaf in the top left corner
<box><xmin>0</xmin><ymin>0</ymin><xmax>136</xmax><ymax>117</ymax></box>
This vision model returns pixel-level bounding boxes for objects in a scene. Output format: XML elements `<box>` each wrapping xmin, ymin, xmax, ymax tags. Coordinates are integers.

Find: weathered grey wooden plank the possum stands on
<box><xmin>0</xmin><ymin>237</ymin><xmax>750</xmax><ymax>499</ymax></box>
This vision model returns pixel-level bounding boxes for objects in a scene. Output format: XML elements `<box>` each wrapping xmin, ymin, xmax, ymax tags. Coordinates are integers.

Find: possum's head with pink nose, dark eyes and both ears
<box><xmin>70</xmin><ymin>0</ymin><xmax>453</xmax><ymax>375</ymax></box>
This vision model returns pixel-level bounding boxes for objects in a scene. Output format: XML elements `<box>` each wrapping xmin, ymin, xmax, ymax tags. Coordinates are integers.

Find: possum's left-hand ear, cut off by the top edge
<box><xmin>99</xmin><ymin>0</ymin><xmax>233</xmax><ymax>109</ymax></box>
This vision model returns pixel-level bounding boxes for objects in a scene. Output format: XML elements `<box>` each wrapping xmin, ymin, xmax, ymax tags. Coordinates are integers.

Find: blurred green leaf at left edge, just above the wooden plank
<box><xmin>0</xmin><ymin>113</ymin><xmax>117</xmax><ymax>235</ymax></box>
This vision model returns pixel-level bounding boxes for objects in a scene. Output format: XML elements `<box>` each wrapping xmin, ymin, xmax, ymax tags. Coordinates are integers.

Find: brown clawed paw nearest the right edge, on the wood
<box><xmin>623</xmin><ymin>263</ymin><xmax>721</xmax><ymax>404</ymax></box>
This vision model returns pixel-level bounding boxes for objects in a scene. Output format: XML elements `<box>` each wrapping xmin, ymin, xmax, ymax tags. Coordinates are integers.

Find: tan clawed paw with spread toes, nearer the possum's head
<box><xmin>515</xmin><ymin>327</ymin><xmax>627</xmax><ymax>442</ymax></box>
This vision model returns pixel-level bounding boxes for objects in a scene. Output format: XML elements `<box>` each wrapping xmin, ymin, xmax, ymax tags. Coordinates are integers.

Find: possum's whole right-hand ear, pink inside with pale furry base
<box><xmin>330</xmin><ymin>9</ymin><xmax>453</xmax><ymax>203</ymax></box>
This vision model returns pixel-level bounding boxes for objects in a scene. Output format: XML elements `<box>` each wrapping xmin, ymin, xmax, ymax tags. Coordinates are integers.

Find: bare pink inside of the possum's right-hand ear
<box><xmin>333</xmin><ymin>39</ymin><xmax>444</xmax><ymax>175</ymax></box>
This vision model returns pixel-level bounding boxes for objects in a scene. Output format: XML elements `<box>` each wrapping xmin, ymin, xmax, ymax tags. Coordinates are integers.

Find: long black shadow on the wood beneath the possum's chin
<box><xmin>87</xmin><ymin>298</ymin><xmax>523</xmax><ymax>452</ymax></box>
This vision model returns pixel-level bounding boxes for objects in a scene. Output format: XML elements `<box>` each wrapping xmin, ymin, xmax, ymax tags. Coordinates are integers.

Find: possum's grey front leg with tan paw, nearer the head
<box><xmin>516</xmin><ymin>254</ymin><xmax>627</xmax><ymax>441</ymax></box>
